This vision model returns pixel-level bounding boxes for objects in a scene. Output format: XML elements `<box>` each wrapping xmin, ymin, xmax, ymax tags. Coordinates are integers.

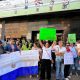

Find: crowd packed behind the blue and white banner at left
<box><xmin>0</xmin><ymin>38</ymin><xmax>32</xmax><ymax>54</ymax></box>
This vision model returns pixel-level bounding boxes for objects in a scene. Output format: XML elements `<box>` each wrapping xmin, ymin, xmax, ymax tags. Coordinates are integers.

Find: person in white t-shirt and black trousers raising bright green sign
<box><xmin>39</xmin><ymin>41</ymin><xmax>52</xmax><ymax>80</ymax></box>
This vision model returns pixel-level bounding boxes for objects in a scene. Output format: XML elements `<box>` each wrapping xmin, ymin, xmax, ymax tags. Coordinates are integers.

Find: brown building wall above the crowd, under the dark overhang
<box><xmin>5</xmin><ymin>19</ymin><xmax>69</xmax><ymax>39</ymax></box>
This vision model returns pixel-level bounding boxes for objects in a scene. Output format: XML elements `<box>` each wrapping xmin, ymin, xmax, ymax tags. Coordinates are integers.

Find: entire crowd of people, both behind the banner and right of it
<box><xmin>0</xmin><ymin>38</ymin><xmax>80</xmax><ymax>80</ymax></box>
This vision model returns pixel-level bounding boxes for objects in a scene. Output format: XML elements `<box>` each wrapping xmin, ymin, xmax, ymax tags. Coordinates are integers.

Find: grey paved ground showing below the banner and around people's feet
<box><xmin>16</xmin><ymin>72</ymin><xmax>80</xmax><ymax>80</ymax></box>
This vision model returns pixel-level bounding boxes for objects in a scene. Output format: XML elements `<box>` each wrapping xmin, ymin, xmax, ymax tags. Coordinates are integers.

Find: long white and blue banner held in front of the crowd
<box><xmin>0</xmin><ymin>50</ymin><xmax>39</xmax><ymax>80</ymax></box>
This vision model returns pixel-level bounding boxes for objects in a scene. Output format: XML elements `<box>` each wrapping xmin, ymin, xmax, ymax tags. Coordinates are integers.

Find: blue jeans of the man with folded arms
<box><xmin>56</xmin><ymin>60</ymin><xmax>64</xmax><ymax>80</ymax></box>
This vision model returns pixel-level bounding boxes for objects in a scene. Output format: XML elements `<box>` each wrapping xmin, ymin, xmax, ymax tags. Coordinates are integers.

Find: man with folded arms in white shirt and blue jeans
<box><xmin>55</xmin><ymin>41</ymin><xmax>66</xmax><ymax>80</ymax></box>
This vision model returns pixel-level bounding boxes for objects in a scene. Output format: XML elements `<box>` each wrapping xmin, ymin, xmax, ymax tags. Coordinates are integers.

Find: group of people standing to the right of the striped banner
<box><xmin>40</xmin><ymin>41</ymin><xmax>80</xmax><ymax>80</ymax></box>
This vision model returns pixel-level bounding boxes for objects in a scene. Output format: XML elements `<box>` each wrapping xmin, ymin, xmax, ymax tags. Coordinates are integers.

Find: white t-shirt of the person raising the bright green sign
<box><xmin>42</xmin><ymin>46</ymin><xmax>52</xmax><ymax>60</ymax></box>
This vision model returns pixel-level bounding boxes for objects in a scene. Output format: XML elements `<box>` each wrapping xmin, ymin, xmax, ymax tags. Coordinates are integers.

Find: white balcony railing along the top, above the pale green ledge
<box><xmin>0</xmin><ymin>0</ymin><xmax>79</xmax><ymax>11</ymax></box>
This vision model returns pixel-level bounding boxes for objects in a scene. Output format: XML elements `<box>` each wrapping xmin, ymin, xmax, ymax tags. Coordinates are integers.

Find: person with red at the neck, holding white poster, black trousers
<box><xmin>64</xmin><ymin>43</ymin><xmax>74</xmax><ymax>80</ymax></box>
